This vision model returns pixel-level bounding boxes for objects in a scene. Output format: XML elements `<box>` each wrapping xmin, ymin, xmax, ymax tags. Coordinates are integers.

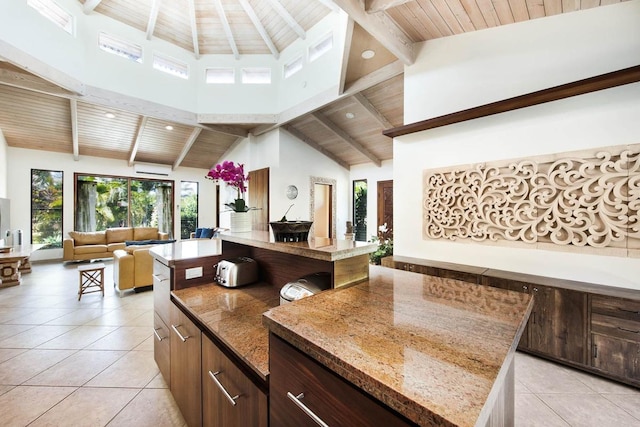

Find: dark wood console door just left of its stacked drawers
<box><xmin>529</xmin><ymin>285</ymin><xmax>587</xmax><ymax>365</ymax></box>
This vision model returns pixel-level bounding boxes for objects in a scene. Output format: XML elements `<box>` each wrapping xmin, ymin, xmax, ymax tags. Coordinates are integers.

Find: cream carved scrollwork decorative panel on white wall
<box><xmin>423</xmin><ymin>145</ymin><xmax>640</xmax><ymax>256</ymax></box>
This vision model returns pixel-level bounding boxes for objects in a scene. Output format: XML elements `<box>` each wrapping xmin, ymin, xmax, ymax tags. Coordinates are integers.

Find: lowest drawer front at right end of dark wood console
<box><xmin>591</xmin><ymin>334</ymin><xmax>640</xmax><ymax>385</ymax></box>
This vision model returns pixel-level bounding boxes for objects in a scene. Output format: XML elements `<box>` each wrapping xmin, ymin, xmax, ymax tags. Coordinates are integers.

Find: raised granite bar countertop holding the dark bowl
<box><xmin>220</xmin><ymin>231</ymin><xmax>378</xmax><ymax>261</ymax></box>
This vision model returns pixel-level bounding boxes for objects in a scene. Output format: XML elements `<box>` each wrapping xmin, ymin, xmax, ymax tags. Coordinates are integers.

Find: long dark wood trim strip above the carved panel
<box><xmin>382</xmin><ymin>65</ymin><xmax>640</xmax><ymax>138</ymax></box>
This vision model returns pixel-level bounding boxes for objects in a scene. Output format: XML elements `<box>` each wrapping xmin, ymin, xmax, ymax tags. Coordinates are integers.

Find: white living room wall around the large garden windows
<box><xmin>6</xmin><ymin>147</ymin><xmax>216</xmax><ymax>260</ymax></box>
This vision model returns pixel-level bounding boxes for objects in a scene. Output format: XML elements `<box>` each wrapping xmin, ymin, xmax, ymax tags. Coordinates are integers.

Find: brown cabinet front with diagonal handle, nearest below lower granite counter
<box><xmin>202</xmin><ymin>336</ymin><xmax>268</xmax><ymax>427</ymax></box>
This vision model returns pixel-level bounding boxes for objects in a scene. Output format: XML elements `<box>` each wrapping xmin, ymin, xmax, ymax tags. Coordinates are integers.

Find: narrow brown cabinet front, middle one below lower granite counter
<box><xmin>171</xmin><ymin>304</ymin><xmax>202</xmax><ymax>427</ymax></box>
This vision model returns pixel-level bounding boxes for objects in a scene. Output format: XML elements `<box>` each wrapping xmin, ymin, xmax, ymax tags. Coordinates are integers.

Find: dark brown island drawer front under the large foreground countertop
<box><xmin>269</xmin><ymin>334</ymin><xmax>415</xmax><ymax>427</ymax></box>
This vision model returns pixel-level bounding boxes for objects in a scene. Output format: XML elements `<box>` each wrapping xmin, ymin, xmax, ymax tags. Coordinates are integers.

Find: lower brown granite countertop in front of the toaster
<box><xmin>171</xmin><ymin>283</ymin><xmax>280</xmax><ymax>381</ymax></box>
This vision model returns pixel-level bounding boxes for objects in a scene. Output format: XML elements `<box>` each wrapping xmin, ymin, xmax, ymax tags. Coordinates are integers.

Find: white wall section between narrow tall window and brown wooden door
<box><xmin>349</xmin><ymin>160</ymin><xmax>396</xmax><ymax>240</ymax></box>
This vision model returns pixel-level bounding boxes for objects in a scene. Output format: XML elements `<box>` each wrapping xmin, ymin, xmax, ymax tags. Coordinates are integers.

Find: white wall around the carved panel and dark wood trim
<box><xmin>394</xmin><ymin>0</ymin><xmax>640</xmax><ymax>289</ymax></box>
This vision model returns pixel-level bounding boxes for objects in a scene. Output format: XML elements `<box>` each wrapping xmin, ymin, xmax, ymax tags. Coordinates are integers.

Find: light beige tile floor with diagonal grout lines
<box><xmin>0</xmin><ymin>261</ymin><xmax>640</xmax><ymax>427</ymax></box>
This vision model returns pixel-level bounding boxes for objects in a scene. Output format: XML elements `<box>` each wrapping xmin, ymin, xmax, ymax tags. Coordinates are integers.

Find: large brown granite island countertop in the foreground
<box><xmin>263</xmin><ymin>266</ymin><xmax>533</xmax><ymax>426</ymax></box>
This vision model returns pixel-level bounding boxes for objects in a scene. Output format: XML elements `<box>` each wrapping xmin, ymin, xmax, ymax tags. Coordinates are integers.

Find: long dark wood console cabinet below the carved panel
<box><xmin>382</xmin><ymin>257</ymin><xmax>640</xmax><ymax>387</ymax></box>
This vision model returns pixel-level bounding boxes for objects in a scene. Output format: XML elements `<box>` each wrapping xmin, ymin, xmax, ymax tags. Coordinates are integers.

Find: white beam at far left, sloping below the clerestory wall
<box><xmin>0</xmin><ymin>39</ymin><xmax>85</xmax><ymax>95</ymax></box>
